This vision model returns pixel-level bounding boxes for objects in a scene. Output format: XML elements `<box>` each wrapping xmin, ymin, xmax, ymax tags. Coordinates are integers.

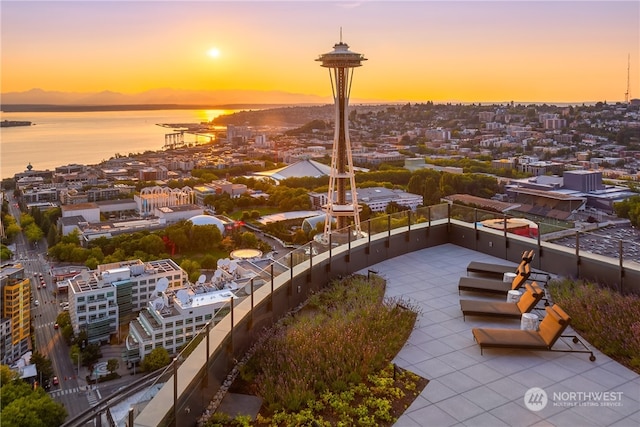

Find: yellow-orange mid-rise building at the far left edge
<box><xmin>0</xmin><ymin>263</ymin><xmax>31</xmax><ymax>365</ymax></box>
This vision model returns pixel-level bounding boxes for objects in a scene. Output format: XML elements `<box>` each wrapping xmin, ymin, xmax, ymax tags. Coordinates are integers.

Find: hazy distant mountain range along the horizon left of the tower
<box><xmin>0</xmin><ymin>89</ymin><xmax>333</xmax><ymax>111</ymax></box>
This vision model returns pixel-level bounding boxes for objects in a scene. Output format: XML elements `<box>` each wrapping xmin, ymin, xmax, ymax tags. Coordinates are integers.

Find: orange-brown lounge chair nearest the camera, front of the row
<box><xmin>471</xmin><ymin>304</ymin><xmax>596</xmax><ymax>362</ymax></box>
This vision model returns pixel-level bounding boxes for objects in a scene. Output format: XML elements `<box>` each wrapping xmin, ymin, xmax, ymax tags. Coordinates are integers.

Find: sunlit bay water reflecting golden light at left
<box><xmin>0</xmin><ymin>110</ymin><xmax>238</xmax><ymax>178</ymax></box>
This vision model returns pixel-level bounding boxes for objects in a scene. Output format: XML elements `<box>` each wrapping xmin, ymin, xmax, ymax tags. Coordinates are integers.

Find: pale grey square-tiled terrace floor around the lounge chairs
<box><xmin>361</xmin><ymin>244</ymin><xmax>640</xmax><ymax>427</ymax></box>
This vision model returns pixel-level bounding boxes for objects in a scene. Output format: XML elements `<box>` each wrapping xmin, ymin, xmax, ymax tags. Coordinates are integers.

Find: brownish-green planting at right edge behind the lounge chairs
<box><xmin>549</xmin><ymin>279</ymin><xmax>640</xmax><ymax>374</ymax></box>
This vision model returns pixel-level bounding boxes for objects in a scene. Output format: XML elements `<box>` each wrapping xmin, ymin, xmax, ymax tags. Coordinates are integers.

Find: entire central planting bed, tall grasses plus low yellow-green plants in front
<box><xmin>206</xmin><ymin>275</ymin><xmax>428</xmax><ymax>427</ymax></box>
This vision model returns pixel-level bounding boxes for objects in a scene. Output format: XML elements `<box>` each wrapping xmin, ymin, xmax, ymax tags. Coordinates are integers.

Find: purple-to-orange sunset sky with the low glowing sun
<box><xmin>0</xmin><ymin>0</ymin><xmax>640</xmax><ymax>103</ymax></box>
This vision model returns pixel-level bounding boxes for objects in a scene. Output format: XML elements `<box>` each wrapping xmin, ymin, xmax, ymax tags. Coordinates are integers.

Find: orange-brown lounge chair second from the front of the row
<box><xmin>460</xmin><ymin>282</ymin><xmax>544</xmax><ymax>319</ymax></box>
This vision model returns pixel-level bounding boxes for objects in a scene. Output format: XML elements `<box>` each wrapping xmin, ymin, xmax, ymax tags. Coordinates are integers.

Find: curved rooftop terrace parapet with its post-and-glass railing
<box><xmin>91</xmin><ymin>204</ymin><xmax>640</xmax><ymax>426</ymax></box>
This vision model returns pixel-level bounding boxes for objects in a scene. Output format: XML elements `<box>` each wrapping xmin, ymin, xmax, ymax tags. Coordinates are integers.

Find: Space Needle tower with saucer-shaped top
<box><xmin>316</xmin><ymin>29</ymin><xmax>367</xmax><ymax>243</ymax></box>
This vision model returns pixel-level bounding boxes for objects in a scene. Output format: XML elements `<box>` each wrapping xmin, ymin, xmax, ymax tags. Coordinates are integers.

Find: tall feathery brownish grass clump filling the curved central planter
<box><xmin>241</xmin><ymin>276</ymin><xmax>417</xmax><ymax>411</ymax></box>
